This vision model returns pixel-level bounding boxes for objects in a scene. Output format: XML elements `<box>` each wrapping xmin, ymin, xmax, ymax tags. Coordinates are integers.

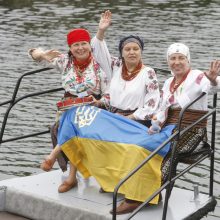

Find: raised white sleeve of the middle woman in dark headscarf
<box><xmin>91</xmin><ymin>36</ymin><xmax>112</xmax><ymax>81</ymax></box>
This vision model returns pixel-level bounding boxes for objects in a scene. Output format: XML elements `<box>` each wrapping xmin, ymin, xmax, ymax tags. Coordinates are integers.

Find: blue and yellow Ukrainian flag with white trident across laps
<box><xmin>58</xmin><ymin>106</ymin><xmax>175</xmax><ymax>204</ymax></box>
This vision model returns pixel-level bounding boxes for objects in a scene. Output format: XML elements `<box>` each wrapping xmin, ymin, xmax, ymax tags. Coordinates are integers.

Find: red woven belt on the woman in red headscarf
<box><xmin>57</xmin><ymin>97</ymin><xmax>93</xmax><ymax>111</ymax></box>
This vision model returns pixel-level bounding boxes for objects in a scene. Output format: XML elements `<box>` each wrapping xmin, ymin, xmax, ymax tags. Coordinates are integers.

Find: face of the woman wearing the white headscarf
<box><xmin>168</xmin><ymin>53</ymin><xmax>190</xmax><ymax>76</ymax></box>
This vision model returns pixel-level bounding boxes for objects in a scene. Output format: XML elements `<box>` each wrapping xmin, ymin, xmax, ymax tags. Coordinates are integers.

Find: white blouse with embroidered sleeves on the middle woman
<box><xmin>91</xmin><ymin>37</ymin><xmax>160</xmax><ymax>120</ymax></box>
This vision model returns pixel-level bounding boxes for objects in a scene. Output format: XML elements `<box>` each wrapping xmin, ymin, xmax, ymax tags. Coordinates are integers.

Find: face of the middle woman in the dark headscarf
<box><xmin>122</xmin><ymin>42</ymin><xmax>142</xmax><ymax>65</ymax></box>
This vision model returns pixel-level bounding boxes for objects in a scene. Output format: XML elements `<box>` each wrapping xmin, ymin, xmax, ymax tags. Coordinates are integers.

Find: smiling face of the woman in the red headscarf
<box><xmin>70</xmin><ymin>41</ymin><xmax>91</xmax><ymax>61</ymax></box>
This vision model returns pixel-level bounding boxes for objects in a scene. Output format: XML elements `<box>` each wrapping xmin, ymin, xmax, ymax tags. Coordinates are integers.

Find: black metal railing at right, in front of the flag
<box><xmin>112</xmin><ymin>93</ymin><xmax>217</xmax><ymax>220</ymax></box>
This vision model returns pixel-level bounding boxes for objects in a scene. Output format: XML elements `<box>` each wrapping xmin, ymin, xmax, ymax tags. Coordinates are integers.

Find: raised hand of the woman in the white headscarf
<box><xmin>204</xmin><ymin>60</ymin><xmax>220</xmax><ymax>86</ymax></box>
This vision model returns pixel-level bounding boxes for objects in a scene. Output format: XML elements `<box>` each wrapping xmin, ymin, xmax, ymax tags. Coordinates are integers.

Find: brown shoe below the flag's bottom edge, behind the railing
<box><xmin>110</xmin><ymin>199</ymin><xmax>142</xmax><ymax>215</ymax></box>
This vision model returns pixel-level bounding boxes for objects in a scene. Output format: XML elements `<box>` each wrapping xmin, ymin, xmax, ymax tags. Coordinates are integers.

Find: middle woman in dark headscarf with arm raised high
<box><xmin>91</xmin><ymin>11</ymin><xmax>160</xmax><ymax>126</ymax></box>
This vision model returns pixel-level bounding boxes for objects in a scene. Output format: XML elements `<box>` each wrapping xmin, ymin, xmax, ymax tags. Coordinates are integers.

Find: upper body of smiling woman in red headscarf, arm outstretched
<box><xmin>29</xmin><ymin>29</ymin><xmax>107</xmax><ymax>100</ymax></box>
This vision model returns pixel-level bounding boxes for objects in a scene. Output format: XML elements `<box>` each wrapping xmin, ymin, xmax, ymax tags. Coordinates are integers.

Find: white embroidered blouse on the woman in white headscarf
<box><xmin>156</xmin><ymin>70</ymin><xmax>220</xmax><ymax>122</ymax></box>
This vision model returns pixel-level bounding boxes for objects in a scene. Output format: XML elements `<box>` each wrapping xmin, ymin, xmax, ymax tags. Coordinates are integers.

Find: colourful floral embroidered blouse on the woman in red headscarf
<box><xmin>42</xmin><ymin>54</ymin><xmax>108</xmax><ymax>97</ymax></box>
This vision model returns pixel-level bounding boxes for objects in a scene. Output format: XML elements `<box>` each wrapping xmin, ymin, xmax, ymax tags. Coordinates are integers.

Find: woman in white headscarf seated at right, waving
<box><xmin>150</xmin><ymin>43</ymin><xmax>220</xmax><ymax>182</ymax></box>
